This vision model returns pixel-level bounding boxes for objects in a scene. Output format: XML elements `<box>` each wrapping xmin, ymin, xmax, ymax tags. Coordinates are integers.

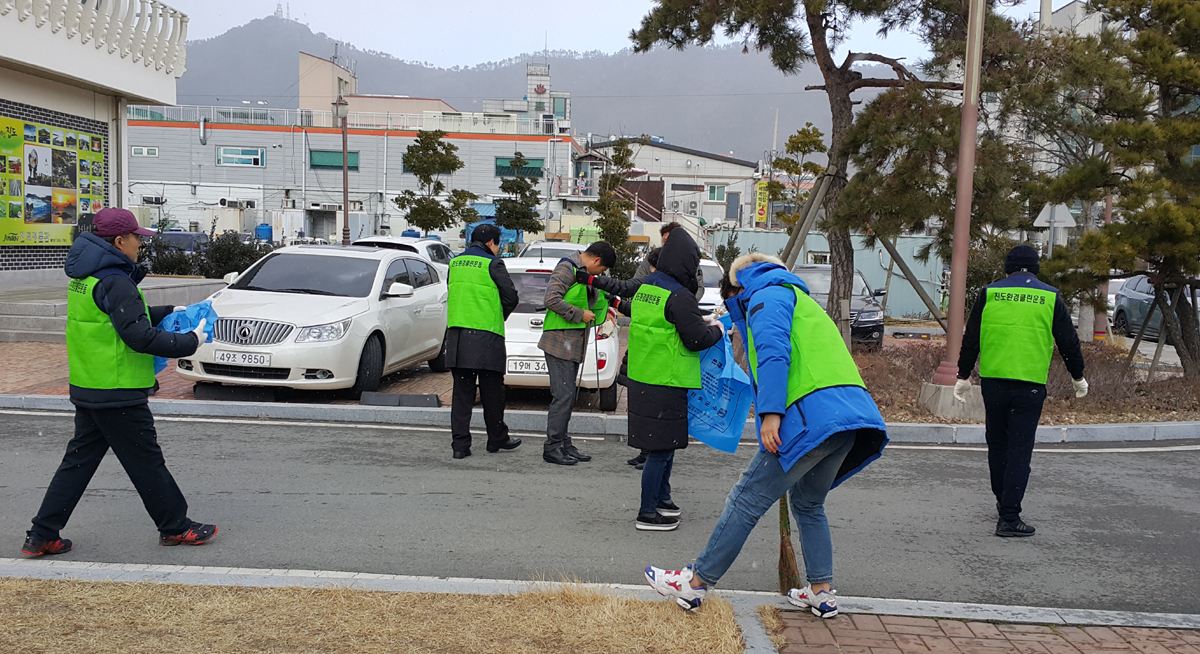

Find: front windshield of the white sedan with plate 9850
<box><xmin>229</xmin><ymin>253</ymin><xmax>379</xmax><ymax>298</ymax></box>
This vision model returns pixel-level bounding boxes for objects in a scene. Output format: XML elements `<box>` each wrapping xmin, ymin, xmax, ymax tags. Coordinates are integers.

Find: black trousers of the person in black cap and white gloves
<box><xmin>980</xmin><ymin>379</ymin><xmax>1046</xmax><ymax>521</ymax></box>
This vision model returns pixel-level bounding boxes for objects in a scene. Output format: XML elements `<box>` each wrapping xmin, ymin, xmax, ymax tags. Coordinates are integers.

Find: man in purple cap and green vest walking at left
<box><xmin>22</xmin><ymin>208</ymin><xmax>217</xmax><ymax>557</ymax></box>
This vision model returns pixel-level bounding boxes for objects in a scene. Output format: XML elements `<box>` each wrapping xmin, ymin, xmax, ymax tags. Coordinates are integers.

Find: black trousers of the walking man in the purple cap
<box><xmin>32</xmin><ymin>404</ymin><xmax>191</xmax><ymax>540</ymax></box>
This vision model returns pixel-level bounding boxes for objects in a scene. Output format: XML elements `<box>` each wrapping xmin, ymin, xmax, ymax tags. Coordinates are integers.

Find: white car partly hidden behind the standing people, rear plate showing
<box><xmin>504</xmin><ymin>256</ymin><xmax>620</xmax><ymax>412</ymax></box>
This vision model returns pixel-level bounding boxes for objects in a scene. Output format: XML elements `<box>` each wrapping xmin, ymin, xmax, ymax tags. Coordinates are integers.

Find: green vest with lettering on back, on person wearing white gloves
<box><xmin>979</xmin><ymin>287</ymin><xmax>1058</xmax><ymax>384</ymax></box>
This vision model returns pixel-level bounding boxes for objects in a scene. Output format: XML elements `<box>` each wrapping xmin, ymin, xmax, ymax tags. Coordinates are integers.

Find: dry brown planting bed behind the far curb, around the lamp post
<box><xmin>854</xmin><ymin>340</ymin><xmax>1200</xmax><ymax>425</ymax></box>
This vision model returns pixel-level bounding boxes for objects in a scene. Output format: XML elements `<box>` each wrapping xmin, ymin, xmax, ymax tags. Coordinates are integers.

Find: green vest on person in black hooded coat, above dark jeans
<box><xmin>629</xmin><ymin>284</ymin><xmax>700</xmax><ymax>389</ymax></box>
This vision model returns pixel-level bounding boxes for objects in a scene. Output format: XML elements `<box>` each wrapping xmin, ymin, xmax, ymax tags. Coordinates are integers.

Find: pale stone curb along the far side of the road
<box><xmin>0</xmin><ymin>395</ymin><xmax>1200</xmax><ymax>444</ymax></box>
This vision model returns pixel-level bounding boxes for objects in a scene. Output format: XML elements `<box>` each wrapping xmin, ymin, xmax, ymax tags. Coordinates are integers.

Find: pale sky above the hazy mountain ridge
<box><xmin>167</xmin><ymin>0</ymin><xmax>1069</xmax><ymax>67</ymax></box>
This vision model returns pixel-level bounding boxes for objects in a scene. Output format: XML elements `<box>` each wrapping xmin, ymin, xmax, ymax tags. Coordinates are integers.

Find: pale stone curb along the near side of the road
<box><xmin>0</xmin><ymin>558</ymin><xmax>1200</xmax><ymax>633</ymax></box>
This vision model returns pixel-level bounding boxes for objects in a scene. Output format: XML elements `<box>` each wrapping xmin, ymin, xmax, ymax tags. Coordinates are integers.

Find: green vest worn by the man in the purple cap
<box><xmin>67</xmin><ymin>277</ymin><xmax>154</xmax><ymax>390</ymax></box>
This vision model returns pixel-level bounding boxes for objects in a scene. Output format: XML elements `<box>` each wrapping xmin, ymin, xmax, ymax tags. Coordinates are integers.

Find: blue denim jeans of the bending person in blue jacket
<box><xmin>696</xmin><ymin>431</ymin><xmax>854</xmax><ymax>584</ymax></box>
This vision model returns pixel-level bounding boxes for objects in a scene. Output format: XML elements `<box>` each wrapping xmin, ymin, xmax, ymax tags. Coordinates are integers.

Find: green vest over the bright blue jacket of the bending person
<box><xmin>746</xmin><ymin>284</ymin><xmax>866</xmax><ymax>407</ymax></box>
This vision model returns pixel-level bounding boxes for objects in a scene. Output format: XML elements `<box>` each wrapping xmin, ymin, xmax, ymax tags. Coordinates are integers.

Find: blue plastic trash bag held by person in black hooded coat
<box><xmin>688</xmin><ymin>335</ymin><xmax>754</xmax><ymax>452</ymax></box>
